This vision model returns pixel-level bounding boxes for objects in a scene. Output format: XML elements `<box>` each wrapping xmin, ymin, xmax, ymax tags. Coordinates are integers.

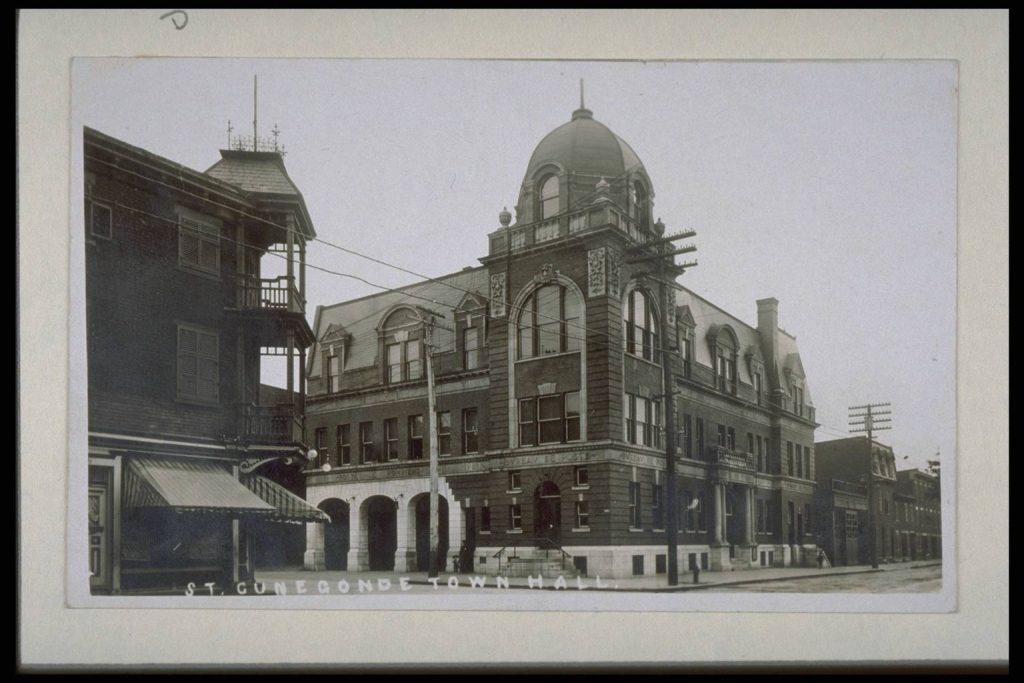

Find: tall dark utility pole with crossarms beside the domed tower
<box><xmin>626</xmin><ymin>219</ymin><xmax>696</xmax><ymax>586</ymax></box>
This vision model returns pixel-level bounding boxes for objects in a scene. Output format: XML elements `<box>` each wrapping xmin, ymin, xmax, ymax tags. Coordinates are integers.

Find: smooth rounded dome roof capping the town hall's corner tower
<box><xmin>526</xmin><ymin>108</ymin><xmax>643</xmax><ymax>180</ymax></box>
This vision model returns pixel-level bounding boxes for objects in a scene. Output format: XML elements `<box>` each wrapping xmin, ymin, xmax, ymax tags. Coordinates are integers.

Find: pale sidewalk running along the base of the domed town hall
<box><xmin>256</xmin><ymin>560</ymin><xmax>941</xmax><ymax>593</ymax></box>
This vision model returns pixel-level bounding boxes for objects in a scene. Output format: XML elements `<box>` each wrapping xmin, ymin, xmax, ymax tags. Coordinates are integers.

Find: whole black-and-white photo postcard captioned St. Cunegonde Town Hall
<box><xmin>68</xmin><ymin>58</ymin><xmax>957</xmax><ymax>612</ymax></box>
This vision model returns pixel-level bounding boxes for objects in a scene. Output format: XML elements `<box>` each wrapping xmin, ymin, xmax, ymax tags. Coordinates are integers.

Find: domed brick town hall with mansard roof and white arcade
<box><xmin>306</xmin><ymin>104</ymin><xmax>816</xmax><ymax>577</ymax></box>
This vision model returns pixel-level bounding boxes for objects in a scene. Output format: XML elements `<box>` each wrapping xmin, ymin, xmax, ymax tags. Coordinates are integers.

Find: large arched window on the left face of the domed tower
<box><xmin>518</xmin><ymin>285</ymin><xmax>583</xmax><ymax>358</ymax></box>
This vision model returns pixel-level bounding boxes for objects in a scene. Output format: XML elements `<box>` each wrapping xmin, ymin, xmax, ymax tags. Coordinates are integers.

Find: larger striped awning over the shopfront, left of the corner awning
<box><xmin>125</xmin><ymin>457</ymin><xmax>278</xmax><ymax>516</ymax></box>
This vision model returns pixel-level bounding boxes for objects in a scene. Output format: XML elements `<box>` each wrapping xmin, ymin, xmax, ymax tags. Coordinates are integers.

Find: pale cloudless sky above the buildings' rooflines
<box><xmin>72</xmin><ymin>58</ymin><xmax>957</xmax><ymax>469</ymax></box>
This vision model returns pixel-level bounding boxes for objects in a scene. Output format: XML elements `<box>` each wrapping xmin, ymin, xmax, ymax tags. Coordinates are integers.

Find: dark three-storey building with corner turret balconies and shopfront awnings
<box><xmin>84</xmin><ymin>128</ymin><xmax>323</xmax><ymax>593</ymax></box>
